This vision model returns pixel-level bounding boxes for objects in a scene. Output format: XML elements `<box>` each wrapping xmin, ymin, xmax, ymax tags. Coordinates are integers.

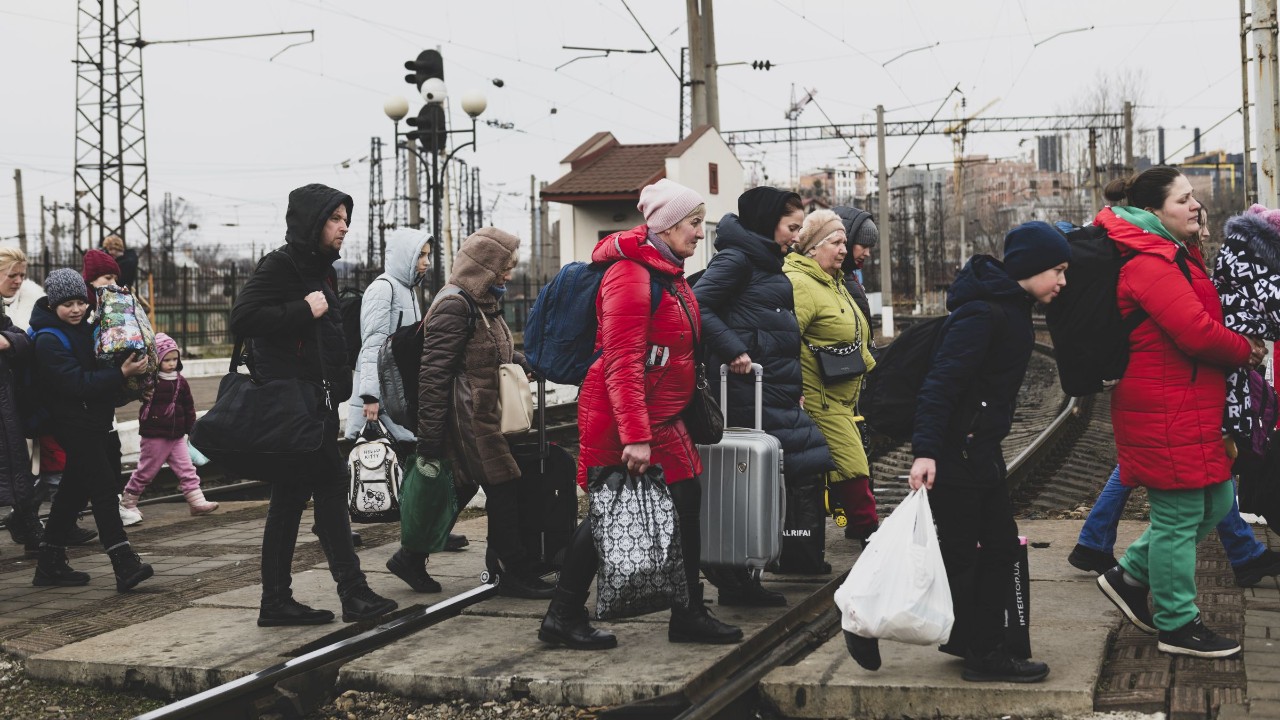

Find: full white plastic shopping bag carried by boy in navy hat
<box><xmin>836</xmin><ymin>488</ymin><xmax>955</xmax><ymax>644</ymax></box>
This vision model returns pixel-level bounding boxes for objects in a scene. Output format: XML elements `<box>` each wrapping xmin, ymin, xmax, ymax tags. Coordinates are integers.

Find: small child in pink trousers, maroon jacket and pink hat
<box><xmin>120</xmin><ymin>333</ymin><xmax>218</xmax><ymax>515</ymax></box>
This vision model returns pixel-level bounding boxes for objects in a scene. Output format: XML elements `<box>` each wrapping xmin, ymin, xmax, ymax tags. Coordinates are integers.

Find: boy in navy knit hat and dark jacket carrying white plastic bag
<box><xmin>910</xmin><ymin>222</ymin><xmax>1071</xmax><ymax>683</ymax></box>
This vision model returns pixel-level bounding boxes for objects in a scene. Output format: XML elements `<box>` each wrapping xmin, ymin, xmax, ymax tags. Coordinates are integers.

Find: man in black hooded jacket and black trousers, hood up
<box><xmin>232</xmin><ymin>184</ymin><xmax>396</xmax><ymax>626</ymax></box>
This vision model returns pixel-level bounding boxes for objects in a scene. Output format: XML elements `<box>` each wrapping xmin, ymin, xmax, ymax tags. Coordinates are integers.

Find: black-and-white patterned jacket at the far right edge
<box><xmin>1213</xmin><ymin>213</ymin><xmax>1280</xmax><ymax>437</ymax></box>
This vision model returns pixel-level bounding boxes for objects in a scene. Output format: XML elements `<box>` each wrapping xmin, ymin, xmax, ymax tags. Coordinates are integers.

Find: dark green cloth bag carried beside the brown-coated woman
<box><xmin>401</xmin><ymin>454</ymin><xmax>458</xmax><ymax>552</ymax></box>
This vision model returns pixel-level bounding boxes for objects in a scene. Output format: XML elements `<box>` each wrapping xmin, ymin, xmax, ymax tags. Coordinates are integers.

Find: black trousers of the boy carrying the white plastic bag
<box><xmin>929</xmin><ymin>480</ymin><xmax>1018</xmax><ymax>655</ymax></box>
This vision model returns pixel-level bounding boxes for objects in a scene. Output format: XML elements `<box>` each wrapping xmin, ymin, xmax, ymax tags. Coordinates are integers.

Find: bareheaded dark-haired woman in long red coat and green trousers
<box><xmin>1094</xmin><ymin>167</ymin><xmax>1266</xmax><ymax>657</ymax></box>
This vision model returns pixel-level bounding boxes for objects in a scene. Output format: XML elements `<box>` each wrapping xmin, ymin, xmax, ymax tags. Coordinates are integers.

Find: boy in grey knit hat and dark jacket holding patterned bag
<box><xmin>31</xmin><ymin>268</ymin><xmax>152</xmax><ymax>592</ymax></box>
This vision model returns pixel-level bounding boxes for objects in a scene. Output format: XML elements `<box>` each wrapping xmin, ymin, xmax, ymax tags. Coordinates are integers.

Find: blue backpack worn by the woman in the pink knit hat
<box><xmin>525</xmin><ymin>256</ymin><xmax>669</xmax><ymax>386</ymax></box>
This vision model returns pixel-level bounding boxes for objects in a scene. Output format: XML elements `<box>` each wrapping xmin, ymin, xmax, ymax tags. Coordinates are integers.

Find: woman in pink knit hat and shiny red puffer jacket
<box><xmin>538</xmin><ymin>178</ymin><xmax>742</xmax><ymax>650</ymax></box>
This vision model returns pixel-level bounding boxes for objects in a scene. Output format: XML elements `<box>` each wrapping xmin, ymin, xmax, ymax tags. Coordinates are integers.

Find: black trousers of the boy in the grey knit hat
<box><xmin>44</xmin><ymin>432</ymin><xmax>129</xmax><ymax>550</ymax></box>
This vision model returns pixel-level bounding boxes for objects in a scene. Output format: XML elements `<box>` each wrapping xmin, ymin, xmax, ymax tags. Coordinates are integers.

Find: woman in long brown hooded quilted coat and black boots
<box><xmin>388</xmin><ymin>228</ymin><xmax>553</xmax><ymax>598</ymax></box>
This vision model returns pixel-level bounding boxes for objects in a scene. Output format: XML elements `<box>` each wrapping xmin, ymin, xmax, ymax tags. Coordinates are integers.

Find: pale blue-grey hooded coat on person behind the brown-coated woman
<box><xmin>347</xmin><ymin>228</ymin><xmax>430</xmax><ymax>441</ymax></box>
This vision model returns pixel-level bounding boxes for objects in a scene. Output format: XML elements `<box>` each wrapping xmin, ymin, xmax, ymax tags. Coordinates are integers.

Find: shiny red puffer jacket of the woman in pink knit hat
<box><xmin>577</xmin><ymin>225</ymin><xmax>703</xmax><ymax>487</ymax></box>
